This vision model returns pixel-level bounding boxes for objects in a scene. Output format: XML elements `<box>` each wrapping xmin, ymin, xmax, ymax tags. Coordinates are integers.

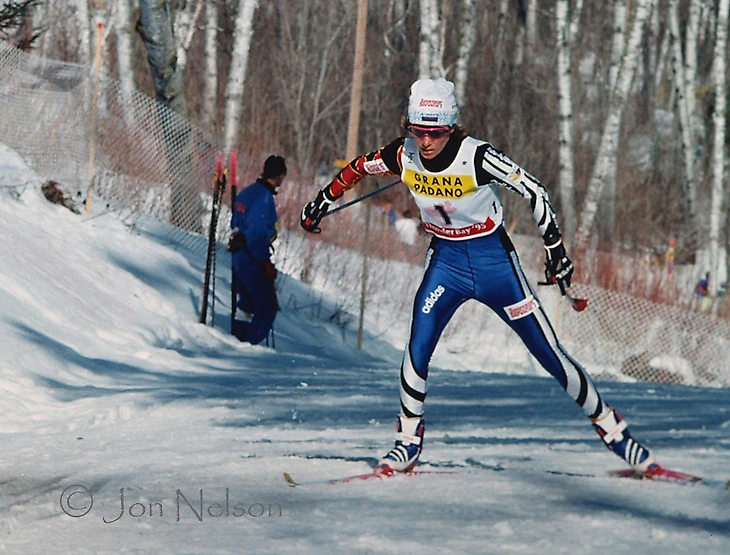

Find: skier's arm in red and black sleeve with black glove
<box><xmin>300</xmin><ymin>137</ymin><xmax>405</xmax><ymax>233</ymax></box>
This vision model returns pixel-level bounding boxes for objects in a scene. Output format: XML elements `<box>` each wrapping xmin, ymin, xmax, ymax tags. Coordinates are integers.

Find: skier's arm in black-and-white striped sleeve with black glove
<box><xmin>475</xmin><ymin>143</ymin><xmax>573</xmax><ymax>294</ymax></box>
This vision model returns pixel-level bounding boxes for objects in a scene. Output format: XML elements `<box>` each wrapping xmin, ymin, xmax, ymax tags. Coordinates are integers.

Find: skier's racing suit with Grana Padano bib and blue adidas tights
<box><xmin>322</xmin><ymin>132</ymin><xmax>647</xmax><ymax>472</ymax></box>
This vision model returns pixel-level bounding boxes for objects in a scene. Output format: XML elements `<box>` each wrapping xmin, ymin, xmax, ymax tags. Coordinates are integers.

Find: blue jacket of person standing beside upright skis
<box><xmin>231</xmin><ymin>179</ymin><xmax>278</xmax><ymax>264</ymax></box>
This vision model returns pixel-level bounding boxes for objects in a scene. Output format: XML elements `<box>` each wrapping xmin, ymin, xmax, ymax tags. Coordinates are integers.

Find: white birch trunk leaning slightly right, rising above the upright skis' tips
<box><xmin>223</xmin><ymin>0</ymin><xmax>258</xmax><ymax>156</ymax></box>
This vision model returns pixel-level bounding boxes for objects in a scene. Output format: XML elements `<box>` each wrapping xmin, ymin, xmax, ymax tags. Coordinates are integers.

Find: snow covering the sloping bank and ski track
<box><xmin>0</xmin><ymin>147</ymin><xmax>730</xmax><ymax>554</ymax></box>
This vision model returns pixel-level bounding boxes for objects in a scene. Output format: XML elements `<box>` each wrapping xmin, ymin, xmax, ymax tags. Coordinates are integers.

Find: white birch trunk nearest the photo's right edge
<box><xmin>710</xmin><ymin>0</ymin><xmax>730</xmax><ymax>291</ymax></box>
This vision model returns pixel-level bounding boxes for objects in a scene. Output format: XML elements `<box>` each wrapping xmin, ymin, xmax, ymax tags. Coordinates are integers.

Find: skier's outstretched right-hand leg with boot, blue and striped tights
<box><xmin>478</xmin><ymin>235</ymin><xmax>655</xmax><ymax>471</ymax></box>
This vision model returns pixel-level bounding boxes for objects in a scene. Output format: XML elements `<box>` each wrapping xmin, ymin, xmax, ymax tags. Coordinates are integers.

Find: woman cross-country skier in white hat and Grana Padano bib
<box><xmin>301</xmin><ymin>78</ymin><xmax>659</xmax><ymax>473</ymax></box>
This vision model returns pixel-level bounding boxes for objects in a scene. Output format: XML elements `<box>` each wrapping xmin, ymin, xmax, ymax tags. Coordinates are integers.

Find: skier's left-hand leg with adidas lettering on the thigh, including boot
<box><xmin>377</xmin><ymin>243</ymin><xmax>468</xmax><ymax>472</ymax></box>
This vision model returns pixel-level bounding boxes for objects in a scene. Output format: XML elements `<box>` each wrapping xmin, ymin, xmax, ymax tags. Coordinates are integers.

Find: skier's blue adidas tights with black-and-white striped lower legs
<box><xmin>400</xmin><ymin>227</ymin><xmax>604</xmax><ymax>418</ymax></box>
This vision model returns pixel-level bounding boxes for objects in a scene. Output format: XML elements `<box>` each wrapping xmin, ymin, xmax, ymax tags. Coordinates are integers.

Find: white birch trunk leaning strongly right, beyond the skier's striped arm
<box><xmin>576</xmin><ymin>0</ymin><xmax>656</xmax><ymax>243</ymax></box>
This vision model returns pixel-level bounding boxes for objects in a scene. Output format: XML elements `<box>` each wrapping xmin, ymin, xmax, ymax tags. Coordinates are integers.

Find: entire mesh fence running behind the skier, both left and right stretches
<box><xmin>0</xmin><ymin>42</ymin><xmax>730</xmax><ymax>387</ymax></box>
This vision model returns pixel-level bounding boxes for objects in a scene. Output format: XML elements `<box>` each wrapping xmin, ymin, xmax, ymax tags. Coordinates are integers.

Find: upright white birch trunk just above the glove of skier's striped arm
<box><xmin>555</xmin><ymin>0</ymin><xmax>576</xmax><ymax>242</ymax></box>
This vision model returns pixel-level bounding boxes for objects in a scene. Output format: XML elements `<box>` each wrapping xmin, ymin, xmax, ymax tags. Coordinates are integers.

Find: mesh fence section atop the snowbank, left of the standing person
<box><xmin>0</xmin><ymin>42</ymin><xmax>220</xmax><ymax>252</ymax></box>
